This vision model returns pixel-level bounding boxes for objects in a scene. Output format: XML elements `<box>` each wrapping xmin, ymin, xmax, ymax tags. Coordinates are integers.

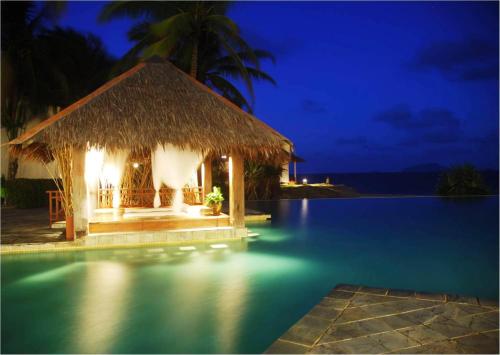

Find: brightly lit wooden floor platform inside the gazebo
<box><xmin>89</xmin><ymin>212</ymin><xmax>230</xmax><ymax>234</ymax></box>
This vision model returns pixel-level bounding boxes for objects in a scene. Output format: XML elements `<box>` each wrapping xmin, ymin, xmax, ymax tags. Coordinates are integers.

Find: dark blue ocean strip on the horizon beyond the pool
<box><xmin>297</xmin><ymin>170</ymin><xmax>498</xmax><ymax>195</ymax></box>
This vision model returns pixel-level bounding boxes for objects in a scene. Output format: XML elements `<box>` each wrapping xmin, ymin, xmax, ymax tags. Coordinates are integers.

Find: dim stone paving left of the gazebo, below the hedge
<box><xmin>0</xmin><ymin>207</ymin><xmax>65</xmax><ymax>244</ymax></box>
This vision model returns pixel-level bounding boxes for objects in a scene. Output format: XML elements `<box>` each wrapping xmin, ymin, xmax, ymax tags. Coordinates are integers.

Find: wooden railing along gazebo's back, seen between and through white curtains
<box><xmin>97</xmin><ymin>186</ymin><xmax>204</xmax><ymax>208</ymax></box>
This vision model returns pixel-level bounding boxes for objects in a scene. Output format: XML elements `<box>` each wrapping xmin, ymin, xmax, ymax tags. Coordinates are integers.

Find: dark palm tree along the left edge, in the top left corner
<box><xmin>1</xmin><ymin>1</ymin><xmax>63</xmax><ymax>179</ymax></box>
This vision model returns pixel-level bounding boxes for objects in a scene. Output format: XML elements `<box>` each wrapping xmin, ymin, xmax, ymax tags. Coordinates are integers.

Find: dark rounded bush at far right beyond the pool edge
<box><xmin>437</xmin><ymin>164</ymin><xmax>490</xmax><ymax>196</ymax></box>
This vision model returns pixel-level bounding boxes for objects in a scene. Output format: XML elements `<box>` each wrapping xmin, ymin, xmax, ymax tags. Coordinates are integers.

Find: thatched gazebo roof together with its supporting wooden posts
<box><xmin>9</xmin><ymin>59</ymin><xmax>292</xmax><ymax>242</ymax></box>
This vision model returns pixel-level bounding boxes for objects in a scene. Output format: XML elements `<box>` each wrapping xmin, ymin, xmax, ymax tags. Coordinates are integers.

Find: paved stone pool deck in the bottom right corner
<box><xmin>266</xmin><ymin>286</ymin><xmax>499</xmax><ymax>354</ymax></box>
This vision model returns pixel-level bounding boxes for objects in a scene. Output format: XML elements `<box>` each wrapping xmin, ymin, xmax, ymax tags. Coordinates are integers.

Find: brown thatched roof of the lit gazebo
<box><xmin>10</xmin><ymin>60</ymin><xmax>291</xmax><ymax>160</ymax></box>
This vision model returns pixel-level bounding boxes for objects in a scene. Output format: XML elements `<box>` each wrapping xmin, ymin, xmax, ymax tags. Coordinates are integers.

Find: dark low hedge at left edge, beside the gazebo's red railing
<box><xmin>5</xmin><ymin>179</ymin><xmax>57</xmax><ymax>208</ymax></box>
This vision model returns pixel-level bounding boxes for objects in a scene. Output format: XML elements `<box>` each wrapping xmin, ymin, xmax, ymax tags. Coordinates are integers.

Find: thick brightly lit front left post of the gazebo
<box><xmin>71</xmin><ymin>149</ymin><xmax>88</xmax><ymax>237</ymax></box>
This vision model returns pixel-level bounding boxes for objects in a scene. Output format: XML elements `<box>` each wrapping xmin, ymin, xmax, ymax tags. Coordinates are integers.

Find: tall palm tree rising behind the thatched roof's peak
<box><xmin>99</xmin><ymin>2</ymin><xmax>274</xmax><ymax>110</ymax></box>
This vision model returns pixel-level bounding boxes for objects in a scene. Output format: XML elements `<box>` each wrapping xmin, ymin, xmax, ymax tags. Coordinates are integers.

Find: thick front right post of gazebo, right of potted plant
<box><xmin>229</xmin><ymin>152</ymin><xmax>245</xmax><ymax>228</ymax></box>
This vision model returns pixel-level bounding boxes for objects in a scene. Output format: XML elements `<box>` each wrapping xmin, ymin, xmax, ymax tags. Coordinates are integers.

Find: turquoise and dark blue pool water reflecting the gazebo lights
<box><xmin>1</xmin><ymin>197</ymin><xmax>499</xmax><ymax>353</ymax></box>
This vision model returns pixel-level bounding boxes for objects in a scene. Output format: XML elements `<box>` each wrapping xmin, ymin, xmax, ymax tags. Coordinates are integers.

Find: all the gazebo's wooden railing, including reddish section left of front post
<box><xmin>47</xmin><ymin>186</ymin><xmax>205</xmax><ymax>225</ymax></box>
